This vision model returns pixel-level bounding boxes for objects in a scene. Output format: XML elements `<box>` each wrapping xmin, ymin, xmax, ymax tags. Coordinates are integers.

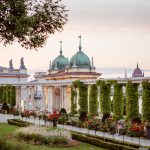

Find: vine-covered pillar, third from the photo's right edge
<box><xmin>113</xmin><ymin>83</ymin><xmax>123</xmax><ymax>120</ymax></box>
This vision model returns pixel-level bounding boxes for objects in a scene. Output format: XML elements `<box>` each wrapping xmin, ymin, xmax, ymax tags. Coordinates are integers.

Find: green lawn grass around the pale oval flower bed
<box><xmin>0</xmin><ymin>123</ymin><xmax>104</xmax><ymax>150</ymax></box>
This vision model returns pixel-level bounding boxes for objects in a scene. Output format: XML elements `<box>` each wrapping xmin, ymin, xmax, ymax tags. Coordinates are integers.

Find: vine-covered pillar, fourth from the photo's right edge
<box><xmin>97</xmin><ymin>81</ymin><xmax>111</xmax><ymax>114</ymax></box>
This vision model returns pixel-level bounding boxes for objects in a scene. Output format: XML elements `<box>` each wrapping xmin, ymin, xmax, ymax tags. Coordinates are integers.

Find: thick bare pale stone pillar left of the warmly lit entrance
<box><xmin>47</xmin><ymin>86</ymin><xmax>54</xmax><ymax>112</ymax></box>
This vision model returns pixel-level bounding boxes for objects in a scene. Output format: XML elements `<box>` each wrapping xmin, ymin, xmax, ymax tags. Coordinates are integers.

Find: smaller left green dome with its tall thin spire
<box><xmin>50</xmin><ymin>41</ymin><xmax>69</xmax><ymax>70</ymax></box>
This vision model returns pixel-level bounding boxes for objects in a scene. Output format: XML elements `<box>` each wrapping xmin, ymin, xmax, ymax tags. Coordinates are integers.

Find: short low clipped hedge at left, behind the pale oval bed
<box><xmin>7</xmin><ymin>119</ymin><xmax>32</xmax><ymax>127</ymax></box>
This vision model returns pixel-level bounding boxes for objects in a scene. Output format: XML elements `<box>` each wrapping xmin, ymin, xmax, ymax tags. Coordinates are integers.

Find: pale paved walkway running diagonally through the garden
<box><xmin>0</xmin><ymin>114</ymin><xmax>150</xmax><ymax>146</ymax></box>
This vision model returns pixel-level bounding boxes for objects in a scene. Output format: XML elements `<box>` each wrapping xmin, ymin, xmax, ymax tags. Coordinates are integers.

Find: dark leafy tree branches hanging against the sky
<box><xmin>0</xmin><ymin>0</ymin><xmax>68</xmax><ymax>49</ymax></box>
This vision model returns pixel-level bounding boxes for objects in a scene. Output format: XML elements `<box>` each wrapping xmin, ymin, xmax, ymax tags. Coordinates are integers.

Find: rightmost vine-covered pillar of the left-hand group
<box><xmin>10</xmin><ymin>86</ymin><xmax>16</xmax><ymax>107</ymax></box>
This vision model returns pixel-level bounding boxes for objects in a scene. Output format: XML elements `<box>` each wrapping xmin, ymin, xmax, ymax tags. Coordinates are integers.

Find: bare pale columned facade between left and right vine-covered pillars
<box><xmin>16</xmin><ymin>85</ymin><xmax>71</xmax><ymax>112</ymax></box>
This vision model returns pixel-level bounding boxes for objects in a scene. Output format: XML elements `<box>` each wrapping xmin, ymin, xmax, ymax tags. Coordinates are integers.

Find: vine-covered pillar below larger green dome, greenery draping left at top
<box><xmin>73</xmin><ymin>80</ymin><xmax>88</xmax><ymax>113</ymax></box>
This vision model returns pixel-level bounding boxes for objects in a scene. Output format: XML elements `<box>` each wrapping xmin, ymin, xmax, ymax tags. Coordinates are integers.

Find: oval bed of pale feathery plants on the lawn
<box><xmin>15</xmin><ymin>126</ymin><xmax>78</xmax><ymax>146</ymax></box>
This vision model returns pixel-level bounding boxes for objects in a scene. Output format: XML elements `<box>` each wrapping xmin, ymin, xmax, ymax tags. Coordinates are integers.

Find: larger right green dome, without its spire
<box><xmin>70</xmin><ymin>51</ymin><xmax>91</xmax><ymax>68</ymax></box>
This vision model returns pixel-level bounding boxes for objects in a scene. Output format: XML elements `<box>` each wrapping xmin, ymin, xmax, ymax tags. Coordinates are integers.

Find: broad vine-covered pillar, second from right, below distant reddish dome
<box><xmin>126</xmin><ymin>81</ymin><xmax>139</xmax><ymax>121</ymax></box>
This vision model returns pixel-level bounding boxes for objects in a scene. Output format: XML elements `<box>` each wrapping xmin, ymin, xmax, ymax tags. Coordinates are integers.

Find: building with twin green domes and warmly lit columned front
<box><xmin>35</xmin><ymin>36</ymin><xmax>101</xmax><ymax>111</ymax></box>
